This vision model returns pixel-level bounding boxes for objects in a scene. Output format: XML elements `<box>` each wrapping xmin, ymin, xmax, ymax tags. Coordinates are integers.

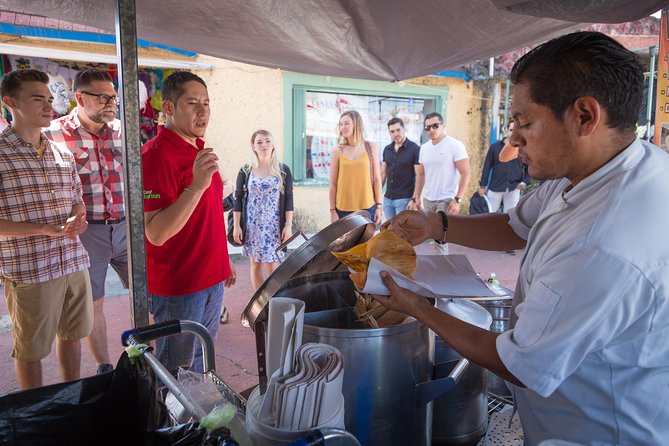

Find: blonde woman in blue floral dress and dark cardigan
<box><xmin>231</xmin><ymin>130</ymin><xmax>293</xmax><ymax>292</ymax></box>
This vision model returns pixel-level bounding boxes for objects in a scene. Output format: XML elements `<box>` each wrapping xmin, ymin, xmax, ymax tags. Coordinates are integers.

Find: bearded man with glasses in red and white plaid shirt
<box><xmin>46</xmin><ymin>69</ymin><xmax>128</xmax><ymax>374</ymax></box>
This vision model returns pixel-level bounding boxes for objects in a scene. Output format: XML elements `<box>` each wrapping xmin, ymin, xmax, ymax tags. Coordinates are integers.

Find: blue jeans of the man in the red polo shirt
<box><xmin>149</xmin><ymin>282</ymin><xmax>225</xmax><ymax>376</ymax></box>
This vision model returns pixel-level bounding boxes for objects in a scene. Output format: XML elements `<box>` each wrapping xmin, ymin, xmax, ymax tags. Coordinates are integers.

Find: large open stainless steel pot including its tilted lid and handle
<box><xmin>242</xmin><ymin>212</ymin><xmax>467</xmax><ymax>446</ymax></box>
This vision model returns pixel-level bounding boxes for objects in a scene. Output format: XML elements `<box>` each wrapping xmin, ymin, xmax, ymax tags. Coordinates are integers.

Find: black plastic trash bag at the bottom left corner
<box><xmin>0</xmin><ymin>353</ymin><xmax>167</xmax><ymax>446</ymax></box>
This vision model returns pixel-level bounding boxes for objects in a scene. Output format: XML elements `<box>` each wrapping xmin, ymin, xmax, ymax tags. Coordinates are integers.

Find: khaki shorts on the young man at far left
<box><xmin>4</xmin><ymin>269</ymin><xmax>93</xmax><ymax>361</ymax></box>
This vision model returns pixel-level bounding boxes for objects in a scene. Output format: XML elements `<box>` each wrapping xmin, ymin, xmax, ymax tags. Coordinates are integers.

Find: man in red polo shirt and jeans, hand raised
<box><xmin>142</xmin><ymin>71</ymin><xmax>235</xmax><ymax>374</ymax></box>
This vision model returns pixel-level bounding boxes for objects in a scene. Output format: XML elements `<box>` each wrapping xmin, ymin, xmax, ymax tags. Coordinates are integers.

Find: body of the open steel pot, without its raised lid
<box><xmin>277</xmin><ymin>272</ymin><xmax>434</xmax><ymax>445</ymax></box>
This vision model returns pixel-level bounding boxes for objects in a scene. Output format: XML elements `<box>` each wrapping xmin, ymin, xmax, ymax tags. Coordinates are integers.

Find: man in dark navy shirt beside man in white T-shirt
<box><xmin>381</xmin><ymin>118</ymin><xmax>422</xmax><ymax>219</ymax></box>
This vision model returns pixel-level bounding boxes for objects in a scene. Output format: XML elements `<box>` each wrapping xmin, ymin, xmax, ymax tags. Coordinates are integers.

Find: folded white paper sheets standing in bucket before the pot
<box><xmin>258</xmin><ymin>297</ymin><xmax>344</xmax><ymax>430</ymax></box>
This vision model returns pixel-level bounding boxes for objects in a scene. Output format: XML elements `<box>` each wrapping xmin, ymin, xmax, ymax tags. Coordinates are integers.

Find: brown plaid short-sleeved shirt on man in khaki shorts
<box><xmin>0</xmin><ymin>127</ymin><xmax>89</xmax><ymax>283</ymax></box>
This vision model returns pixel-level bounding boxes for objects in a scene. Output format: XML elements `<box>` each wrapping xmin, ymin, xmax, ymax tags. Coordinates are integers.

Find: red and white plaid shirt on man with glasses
<box><xmin>45</xmin><ymin>108</ymin><xmax>125</xmax><ymax>220</ymax></box>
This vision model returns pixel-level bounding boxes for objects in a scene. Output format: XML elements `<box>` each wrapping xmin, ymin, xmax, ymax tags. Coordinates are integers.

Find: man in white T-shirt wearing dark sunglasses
<box><xmin>416</xmin><ymin>113</ymin><xmax>470</xmax><ymax>214</ymax></box>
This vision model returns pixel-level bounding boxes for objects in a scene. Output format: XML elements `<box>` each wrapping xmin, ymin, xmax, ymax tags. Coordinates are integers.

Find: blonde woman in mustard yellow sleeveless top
<box><xmin>330</xmin><ymin>110</ymin><xmax>383</xmax><ymax>224</ymax></box>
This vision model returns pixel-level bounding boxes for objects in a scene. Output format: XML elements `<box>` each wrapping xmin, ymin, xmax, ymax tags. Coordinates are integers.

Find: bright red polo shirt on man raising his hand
<box><xmin>142</xmin><ymin>126</ymin><xmax>230</xmax><ymax>296</ymax></box>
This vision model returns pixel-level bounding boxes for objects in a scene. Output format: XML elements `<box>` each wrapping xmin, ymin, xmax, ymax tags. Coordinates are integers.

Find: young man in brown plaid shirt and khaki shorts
<box><xmin>0</xmin><ymin>70</ymin><xmax>93</xmax><ymax>389</ymax></box>
